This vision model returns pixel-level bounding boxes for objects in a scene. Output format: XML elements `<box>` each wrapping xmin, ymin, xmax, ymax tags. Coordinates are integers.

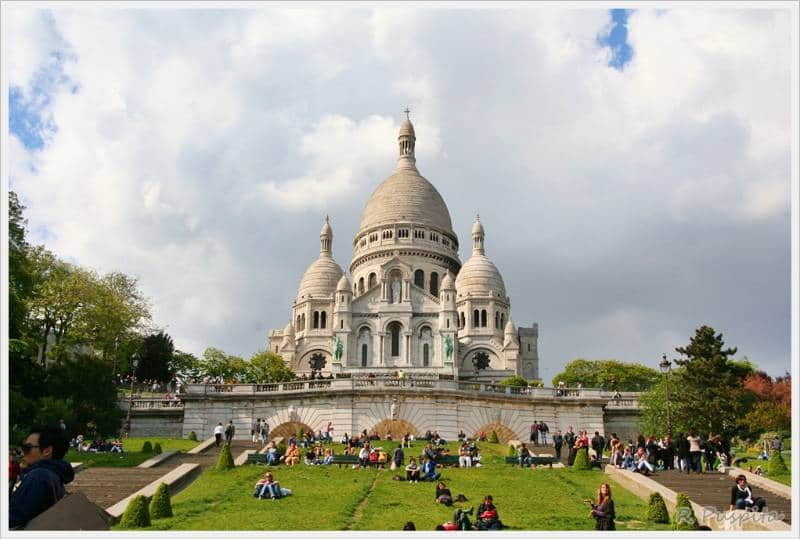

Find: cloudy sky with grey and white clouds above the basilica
<box><xmin>3</xmin><ymin>4</ymin><xmax>796</xmax><ymax>380</ymax></box>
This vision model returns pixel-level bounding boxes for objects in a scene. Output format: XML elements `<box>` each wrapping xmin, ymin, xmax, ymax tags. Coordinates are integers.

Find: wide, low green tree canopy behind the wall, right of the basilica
<box><xmin>553</xmin><ymin>359</ymin><xmax>661</xmax><ymax>391</ymax></box>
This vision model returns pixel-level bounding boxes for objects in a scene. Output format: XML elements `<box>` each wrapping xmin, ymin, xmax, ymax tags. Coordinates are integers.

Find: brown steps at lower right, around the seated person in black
<box><xmin>650</xmin><ymin>470</ymin><xmax>792</xmax><ymax>524</ymax></box>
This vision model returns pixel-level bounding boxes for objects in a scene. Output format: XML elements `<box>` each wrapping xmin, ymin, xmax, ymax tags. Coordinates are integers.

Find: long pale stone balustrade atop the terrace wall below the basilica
<box><xmin>184</xmin><ymin>376</ymin><xmax>639</xmax><ymax>409</ymax></box>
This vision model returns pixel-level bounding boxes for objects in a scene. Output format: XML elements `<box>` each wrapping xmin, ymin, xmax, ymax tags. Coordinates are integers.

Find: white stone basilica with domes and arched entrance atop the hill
<box><xmin>269</xmin><ymin>119</ymin><xmax>539</xmax><ymax>381</ymax></box>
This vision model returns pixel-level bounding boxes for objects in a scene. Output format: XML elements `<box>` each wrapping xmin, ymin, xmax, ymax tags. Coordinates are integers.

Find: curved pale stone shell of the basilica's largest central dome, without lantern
<box><xmin>360</xmin><ymin>168</ymin><xmax>453</xmax><ymax>234</ymax></box>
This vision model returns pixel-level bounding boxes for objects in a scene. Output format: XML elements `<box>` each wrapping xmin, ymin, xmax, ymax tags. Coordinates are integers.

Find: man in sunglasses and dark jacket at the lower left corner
<box><xmin>9</xmin><ymin>426</ymin><xmax>75</xmax><ymax>529</ymax></box>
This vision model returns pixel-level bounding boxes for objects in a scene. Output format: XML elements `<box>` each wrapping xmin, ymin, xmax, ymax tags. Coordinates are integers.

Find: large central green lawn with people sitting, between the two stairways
<box><xmin>130</xmin><ymin>442</ymin><xmax>669</xmax><ymax>530</ymax></box>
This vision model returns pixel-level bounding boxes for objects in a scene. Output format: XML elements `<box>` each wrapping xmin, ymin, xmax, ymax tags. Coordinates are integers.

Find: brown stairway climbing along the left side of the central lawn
<box><xmin>67</xmin><ymin>440</ymin><xmax>253</xmax><ymax>509</ymax></box>
